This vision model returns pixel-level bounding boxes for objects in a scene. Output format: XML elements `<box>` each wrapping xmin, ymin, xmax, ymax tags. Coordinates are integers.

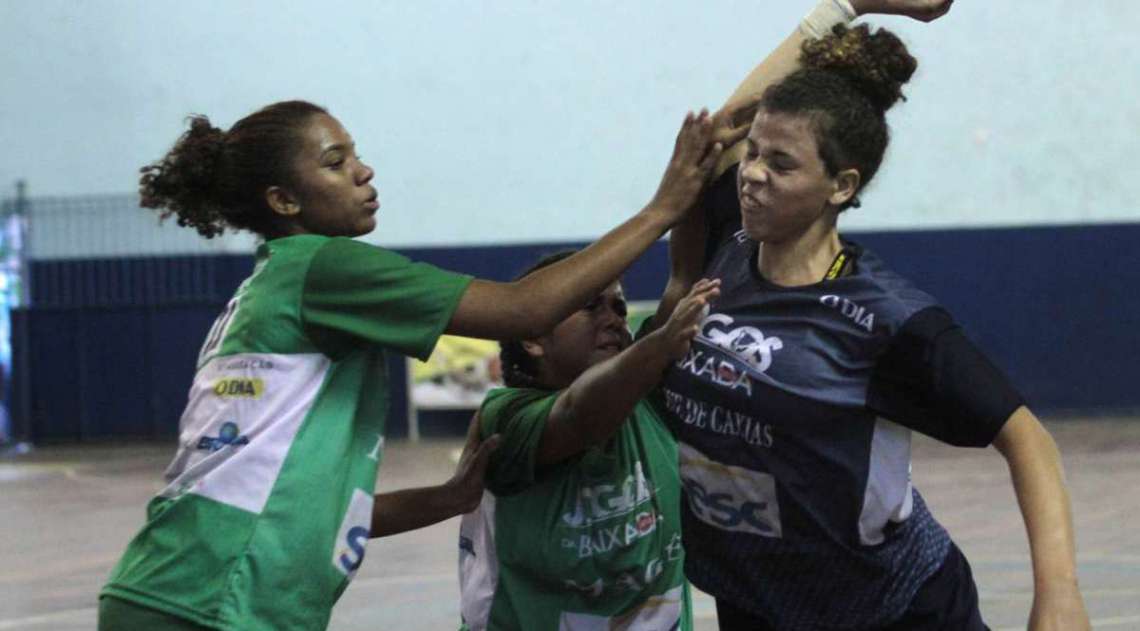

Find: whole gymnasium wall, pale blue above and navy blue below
<box><xmin>0</xmin><ymin>0</ymin><xmax>1140</xmax><ymax>440</ymax></box>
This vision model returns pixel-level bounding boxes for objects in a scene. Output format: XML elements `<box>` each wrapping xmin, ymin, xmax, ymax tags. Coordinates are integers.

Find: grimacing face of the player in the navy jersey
<box><xmin>736</xmin><ymin>109</ymin><xmax>836</xmax><ymax>243</ymax></box>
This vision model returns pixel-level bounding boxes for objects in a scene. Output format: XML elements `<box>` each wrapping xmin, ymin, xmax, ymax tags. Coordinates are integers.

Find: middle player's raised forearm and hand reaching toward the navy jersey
<box><xmin>535</xmin><ymin>280</ymin><xmax>720</xmax><ymax>465</ymax></box>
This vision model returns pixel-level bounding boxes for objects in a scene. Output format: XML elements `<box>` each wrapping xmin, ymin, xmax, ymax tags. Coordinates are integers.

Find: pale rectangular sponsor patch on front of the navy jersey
<box><xmin>677</xmin><ymin>443</ymin><xmax>783</xmax><ymax>538</ymax></box>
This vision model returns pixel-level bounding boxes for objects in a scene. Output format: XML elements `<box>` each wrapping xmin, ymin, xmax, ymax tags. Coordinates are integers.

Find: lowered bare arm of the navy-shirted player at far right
<box><xmin>994</xmin><ymin>407</ymin><xmax>1090</xmax><ymax>631</ymax></box>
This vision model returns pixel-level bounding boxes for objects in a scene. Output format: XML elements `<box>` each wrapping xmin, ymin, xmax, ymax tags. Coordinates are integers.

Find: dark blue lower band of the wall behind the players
<box><xmin>11</xmin><ymin>223</ymin><xmax>1140</xmax><ymax>442</ymax></box>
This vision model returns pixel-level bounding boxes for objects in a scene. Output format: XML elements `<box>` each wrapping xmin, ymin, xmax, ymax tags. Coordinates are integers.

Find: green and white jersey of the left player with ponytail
<box><xmin>103</xmin><ymin>235</ymin><xmax>471</xmax><ymax>631</ymax></box>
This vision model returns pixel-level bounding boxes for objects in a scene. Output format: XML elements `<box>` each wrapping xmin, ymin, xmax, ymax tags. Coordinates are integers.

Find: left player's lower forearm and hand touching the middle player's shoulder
<box><xmin>371</xmin><ymin>415</ymin><xmax>499</xmax><ymax>538</ymax></box>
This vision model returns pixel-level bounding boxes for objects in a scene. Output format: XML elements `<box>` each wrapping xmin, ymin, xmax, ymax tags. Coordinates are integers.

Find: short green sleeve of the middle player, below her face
<box><xmin>479</xmin><ymin>388</ymin><xmax>559</xmax><ymax>495</ymax></box>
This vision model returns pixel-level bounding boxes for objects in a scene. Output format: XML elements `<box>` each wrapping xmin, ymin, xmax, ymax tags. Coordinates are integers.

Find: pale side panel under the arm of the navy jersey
<box><xmin>858</xmin><ymin>418</ymin><xmax>914</xmax><ymax>546</ymax></box>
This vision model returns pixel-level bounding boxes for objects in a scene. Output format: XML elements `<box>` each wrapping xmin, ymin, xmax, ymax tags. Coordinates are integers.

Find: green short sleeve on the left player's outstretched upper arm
<box><xmin>301</xmin><ymin>238</ymin><xmax>471</xmax><ymax>360</ymax></box>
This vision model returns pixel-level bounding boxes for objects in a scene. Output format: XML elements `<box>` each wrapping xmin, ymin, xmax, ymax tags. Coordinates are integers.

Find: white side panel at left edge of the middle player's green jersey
<box><xmin>459</xmin><ymin>491</ymin><xmax>498</xmax><ymax>631</ymax></box>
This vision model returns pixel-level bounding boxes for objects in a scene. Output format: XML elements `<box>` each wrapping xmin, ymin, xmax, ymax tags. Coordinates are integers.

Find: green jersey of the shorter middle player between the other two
<box><xmin>459</xmin><ymin>388</ymin><xmax>692</xmax><ymax>631</ymax></box>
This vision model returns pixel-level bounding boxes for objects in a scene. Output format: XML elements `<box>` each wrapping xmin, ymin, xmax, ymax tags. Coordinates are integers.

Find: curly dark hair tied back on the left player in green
<box><xmin>139</xmin><ymin>100</ymin><xmax>328</xmax><ymax>239</ymax></box>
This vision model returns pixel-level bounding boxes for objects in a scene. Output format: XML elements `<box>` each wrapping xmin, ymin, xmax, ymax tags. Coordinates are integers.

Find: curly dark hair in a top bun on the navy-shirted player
<box><xmin>760</xmin><ymin>24</ymin><xmax>918</xmax><ymax>211</ymax></box>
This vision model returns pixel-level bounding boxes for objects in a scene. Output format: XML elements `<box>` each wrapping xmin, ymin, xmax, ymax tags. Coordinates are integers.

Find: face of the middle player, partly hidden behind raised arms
<box><xmin>537</xmin><ymin>282</ymin><xmax>632</xmax><ymax>387</ymax></box>
